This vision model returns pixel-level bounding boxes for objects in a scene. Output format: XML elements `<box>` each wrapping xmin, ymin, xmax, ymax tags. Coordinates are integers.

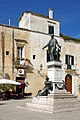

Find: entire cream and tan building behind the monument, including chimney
<box><xmin>0</xmin><ymin>9</ymin><xmax>80</xmax><ymax>95</ymax></box>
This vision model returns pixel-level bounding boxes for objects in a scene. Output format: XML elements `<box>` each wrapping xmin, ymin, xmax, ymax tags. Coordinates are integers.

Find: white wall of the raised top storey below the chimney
<box><xmin>19</xmin><ymin>13</ymin><xmax>60</xmax><ymax>36</ymax></box>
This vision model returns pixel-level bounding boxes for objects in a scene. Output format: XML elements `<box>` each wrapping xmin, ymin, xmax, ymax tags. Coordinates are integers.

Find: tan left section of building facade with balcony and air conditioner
<box><xmin>0</xmin><ymin>25</ymin><xmax>33</xmax><ymax>95</ymax></box>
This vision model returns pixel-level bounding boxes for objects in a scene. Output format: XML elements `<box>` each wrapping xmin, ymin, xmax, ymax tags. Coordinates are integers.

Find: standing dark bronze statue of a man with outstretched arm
<box><xmin>42</xmin><ymin>35</ymin><xmax>61</xmax><ymax>61</ymax></box>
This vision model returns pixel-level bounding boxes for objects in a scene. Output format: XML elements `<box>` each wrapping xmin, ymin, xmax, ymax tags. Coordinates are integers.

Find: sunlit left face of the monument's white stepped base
<box><xmin>26</xmin><ymin>96</ymin><xmax>54</xmax><ymax>113</ymax></box>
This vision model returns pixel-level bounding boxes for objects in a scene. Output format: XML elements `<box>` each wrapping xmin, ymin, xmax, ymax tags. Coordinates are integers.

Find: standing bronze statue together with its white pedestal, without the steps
<box><xmin>42</xmin><ymin>35</ymin><xmax>65</xmax><ymax>93</ymax></box>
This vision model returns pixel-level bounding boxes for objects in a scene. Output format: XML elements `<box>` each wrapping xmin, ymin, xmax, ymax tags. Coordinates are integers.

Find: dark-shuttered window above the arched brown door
<box><xmin>65</xmin><ymin>55</ymin><xmax>74</xmax><ymax>69</ymax></box>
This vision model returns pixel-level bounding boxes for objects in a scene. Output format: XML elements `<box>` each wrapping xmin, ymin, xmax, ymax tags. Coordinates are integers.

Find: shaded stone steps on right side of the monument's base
<box><xmin>54</xmin><ymin>98</ymin><xmax>80</xmax><ymax>112</ymax></box>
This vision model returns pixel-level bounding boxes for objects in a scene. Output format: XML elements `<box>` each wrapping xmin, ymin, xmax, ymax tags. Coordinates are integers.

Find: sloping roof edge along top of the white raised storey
<box><xmin>18</xmin><ymin>11</ymin><xmax>60</xmax><ymax>22</ymax></box>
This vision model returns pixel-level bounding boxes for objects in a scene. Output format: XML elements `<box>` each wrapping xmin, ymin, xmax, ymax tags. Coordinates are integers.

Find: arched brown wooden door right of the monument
<box><xmin>65</xmin><ymin>74</ymin><xmax>72</xmax><ymax>93</ymax></box>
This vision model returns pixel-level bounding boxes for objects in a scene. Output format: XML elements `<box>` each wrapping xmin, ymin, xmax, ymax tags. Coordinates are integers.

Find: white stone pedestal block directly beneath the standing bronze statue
<box><xmin>47</xmin><ymin>61</ymin><xmax>64</xmax><ymax>93</ymax></box>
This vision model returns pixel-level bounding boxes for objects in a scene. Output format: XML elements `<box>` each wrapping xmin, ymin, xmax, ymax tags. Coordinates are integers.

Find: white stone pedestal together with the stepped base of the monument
<box><xmin>26</xmin><ymin>61</ymin><xmax>77</xmax><ymax>113</ymax></box>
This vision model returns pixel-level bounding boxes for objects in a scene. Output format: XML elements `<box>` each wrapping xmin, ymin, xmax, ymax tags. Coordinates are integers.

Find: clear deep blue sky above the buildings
<box><xmin>0</xmin><ymin>0</ymin><xmax>80</xmax><ymax>39</ymax></box>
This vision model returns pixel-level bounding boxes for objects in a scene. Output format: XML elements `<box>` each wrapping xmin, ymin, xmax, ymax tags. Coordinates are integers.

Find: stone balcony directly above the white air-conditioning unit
<box><xmin>14</xmin><ymin>58</ymin><xmax>33</xmax><ymax>71</ymax></box>
